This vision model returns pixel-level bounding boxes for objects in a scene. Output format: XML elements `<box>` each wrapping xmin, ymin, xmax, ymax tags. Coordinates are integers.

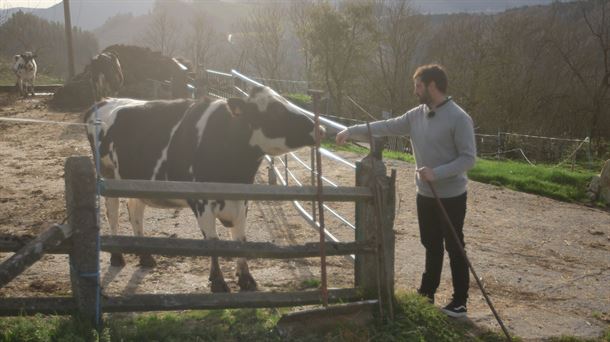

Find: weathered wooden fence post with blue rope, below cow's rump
<box><xmin>65</xmin><ymin>156</ymin><xmax>101</xmax><ymax>327</ymax></box>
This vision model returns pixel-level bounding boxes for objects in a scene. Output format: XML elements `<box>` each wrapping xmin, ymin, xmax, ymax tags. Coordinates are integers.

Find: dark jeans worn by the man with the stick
<box><xmin>417</xmin><ymin>193</ymin><xmax>470</xmax><ymax>301</ymax></box>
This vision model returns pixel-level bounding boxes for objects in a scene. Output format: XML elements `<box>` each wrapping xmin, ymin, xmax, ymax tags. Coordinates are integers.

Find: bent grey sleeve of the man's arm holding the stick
<box><xmin>432</xmin><ymin>115</ymin><xmax>477</xmax><ymax>179</ymax></box>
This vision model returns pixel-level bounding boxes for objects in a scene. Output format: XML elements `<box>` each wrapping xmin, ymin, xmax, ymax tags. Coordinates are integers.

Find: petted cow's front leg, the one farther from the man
<box><xmin>189</xmin><ymin>201</ymin><xmax>231</xmax><ymax>292</ymax></box>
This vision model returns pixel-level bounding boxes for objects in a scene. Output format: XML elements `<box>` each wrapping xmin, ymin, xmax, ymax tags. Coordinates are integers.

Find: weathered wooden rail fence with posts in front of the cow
<box><xmin>0</xmin><ymin>155</ymin><xmax>395</xmax><ymax>321</ymax></box>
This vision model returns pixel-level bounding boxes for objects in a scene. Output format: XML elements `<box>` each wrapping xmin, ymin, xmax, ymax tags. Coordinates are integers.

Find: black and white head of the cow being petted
<box><xmin>227</xmin><ymin>87</ymin><xmax>324</xmax><ymax>156</ymax></box>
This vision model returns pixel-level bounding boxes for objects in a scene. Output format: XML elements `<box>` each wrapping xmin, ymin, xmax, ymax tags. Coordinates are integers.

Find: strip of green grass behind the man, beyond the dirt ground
<box><xmin>323</xmin><ymin>142</ymin><xmax>603</xmax><ymax>206</ymax></box>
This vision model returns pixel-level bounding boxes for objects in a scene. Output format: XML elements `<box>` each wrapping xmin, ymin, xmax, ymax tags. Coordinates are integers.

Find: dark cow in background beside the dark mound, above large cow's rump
<box><xmin>90</xmin><ymin>51</ymin><xmax>124</xmax><ymax>101</ymax></box>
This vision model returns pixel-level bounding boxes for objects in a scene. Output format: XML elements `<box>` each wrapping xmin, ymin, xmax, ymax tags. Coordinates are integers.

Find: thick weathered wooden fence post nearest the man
<box><xmin>355</xmin><ymin>141</ymin><xmax>396</xmax><ymax>317</ymax></box>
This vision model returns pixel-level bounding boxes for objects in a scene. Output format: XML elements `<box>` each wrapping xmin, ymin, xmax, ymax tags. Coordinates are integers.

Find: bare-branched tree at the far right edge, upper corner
<box><xmin>547</xmin><ymin>0</ymin><xmax>610</xmax><ymax>156</ymax></box>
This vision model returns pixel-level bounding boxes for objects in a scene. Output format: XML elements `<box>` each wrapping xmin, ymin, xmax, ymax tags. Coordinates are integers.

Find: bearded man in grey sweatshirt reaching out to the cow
<box><xmin>336</xmin><ymin>64</ymin><xmax>476</xmax><ymax>317</ymax></box>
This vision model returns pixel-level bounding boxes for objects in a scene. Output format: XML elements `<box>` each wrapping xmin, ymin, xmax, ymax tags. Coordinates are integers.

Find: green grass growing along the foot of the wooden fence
<box><xmin>0</xmin><ymin>293</ymin><xmax>516</xmax><ymax>342</ymax></box>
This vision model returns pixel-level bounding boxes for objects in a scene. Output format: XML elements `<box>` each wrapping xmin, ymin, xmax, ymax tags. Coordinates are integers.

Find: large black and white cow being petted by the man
<box><xmin>85</xmin><ymin>87</ymin><xmax>324</xmax><ymax>292</ymax></box>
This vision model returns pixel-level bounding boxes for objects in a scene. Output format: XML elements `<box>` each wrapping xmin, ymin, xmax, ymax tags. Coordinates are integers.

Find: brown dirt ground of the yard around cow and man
<box><xmin>0</xmin><ymin>95</ymin><xmax>610</xmax><ymax>340</ymax></box>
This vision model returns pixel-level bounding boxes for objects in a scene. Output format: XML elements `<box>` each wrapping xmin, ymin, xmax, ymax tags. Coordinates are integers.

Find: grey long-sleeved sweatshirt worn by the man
<box><xmin>348</xmin><ymin>101</ymin><xmax>476</xmax><ymax>198</ymax></box>
